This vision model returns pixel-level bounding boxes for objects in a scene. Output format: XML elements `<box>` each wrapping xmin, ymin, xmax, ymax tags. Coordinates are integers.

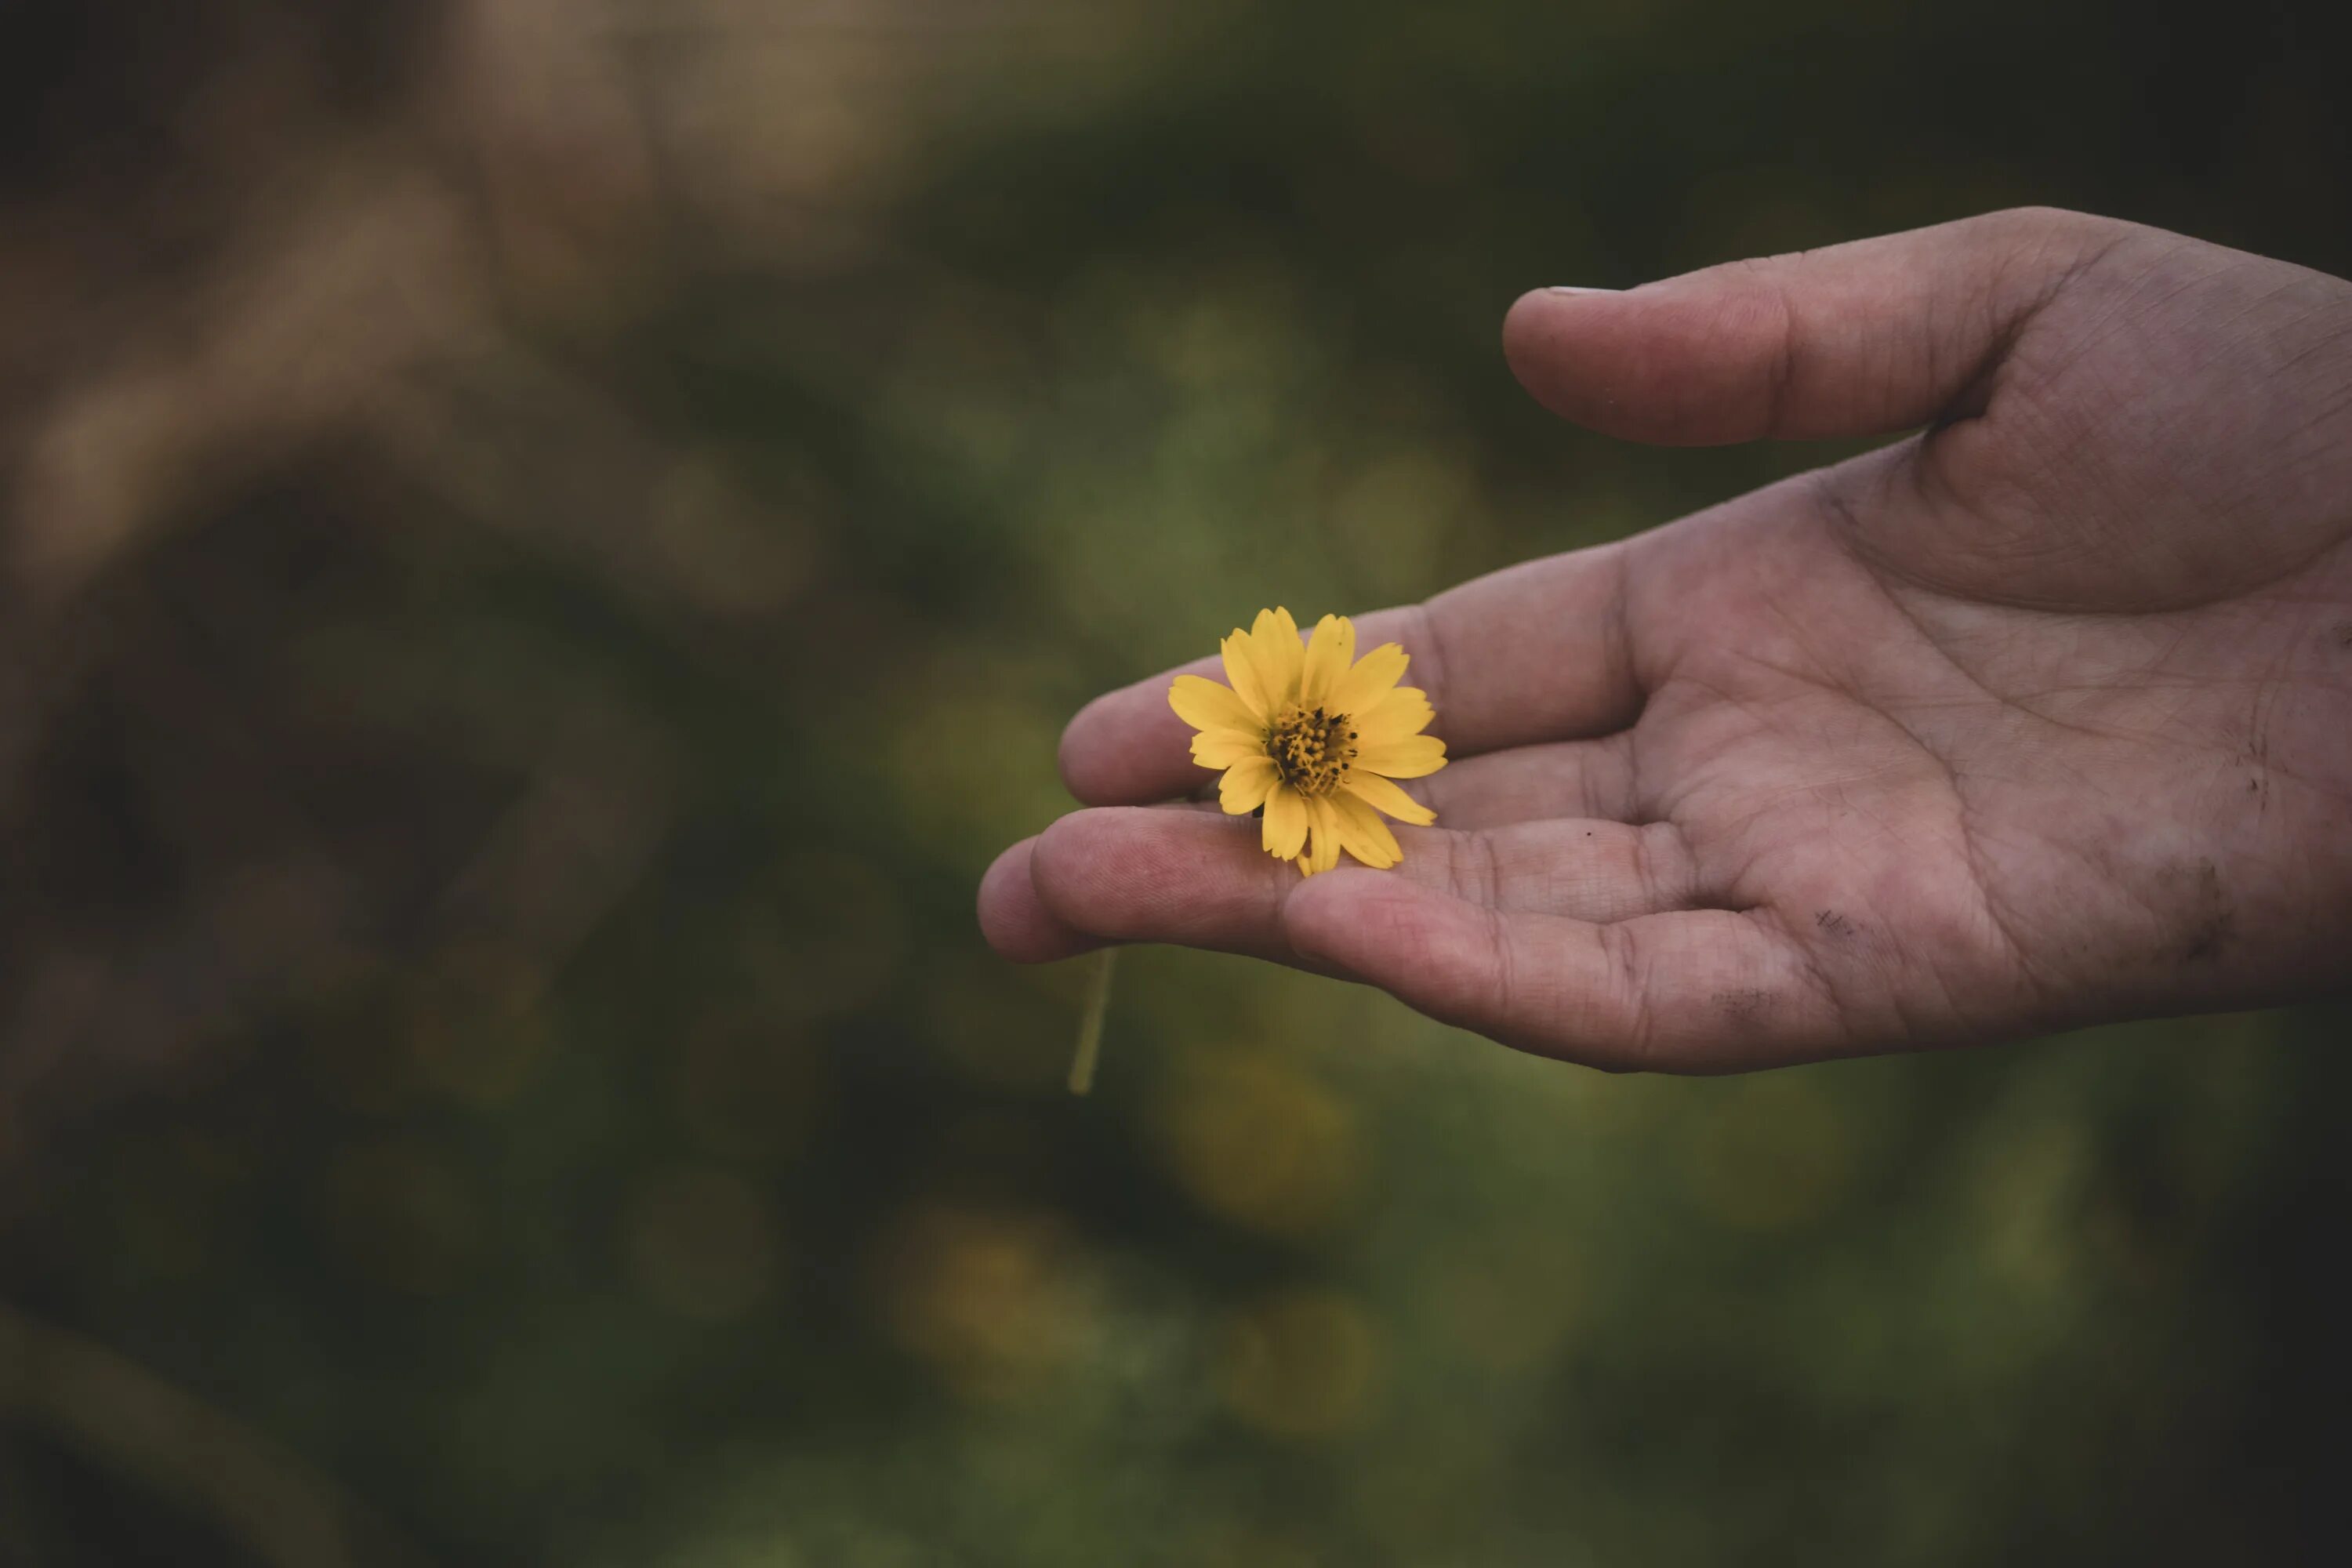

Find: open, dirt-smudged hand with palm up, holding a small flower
<box><xmin>981</xmin><ymin>212</ymin><xmax>2352</xmax><ymax>1072</ymax></box>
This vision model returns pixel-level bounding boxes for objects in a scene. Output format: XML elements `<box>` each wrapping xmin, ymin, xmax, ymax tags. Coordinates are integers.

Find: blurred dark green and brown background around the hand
<box><xmin>0</xmin><ymin>0</ymin><xmax>2352</xmax><ymax>1568</ymax></box>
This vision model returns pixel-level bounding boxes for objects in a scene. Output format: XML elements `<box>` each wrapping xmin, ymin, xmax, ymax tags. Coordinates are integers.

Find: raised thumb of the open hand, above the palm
<box><xmin>1503</xmin><ymin>207</ymin><xmax>2131</xmax><ymax>447</ymax></box>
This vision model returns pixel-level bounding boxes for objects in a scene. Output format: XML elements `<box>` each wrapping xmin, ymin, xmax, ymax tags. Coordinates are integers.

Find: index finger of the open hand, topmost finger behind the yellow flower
<box><xmin>1061</xmin><ymin>541</ymin><xmax>1642</xmax><ymax>806</ymax></box>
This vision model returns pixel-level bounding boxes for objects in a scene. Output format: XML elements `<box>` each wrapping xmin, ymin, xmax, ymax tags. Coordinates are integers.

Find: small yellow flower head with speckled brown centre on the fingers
<box><xmin>1169</xmin><ymin>609</ymin><xmax>1446</xmax><ymax>877</ymax></box>
